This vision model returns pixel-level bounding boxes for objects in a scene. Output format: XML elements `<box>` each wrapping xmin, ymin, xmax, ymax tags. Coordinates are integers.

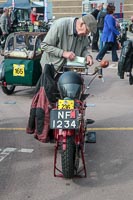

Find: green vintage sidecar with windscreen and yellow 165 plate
<box><xmin>0</xmin><ymin>32</ymin><xmax>46</xmax><ymax>95</ymax></box>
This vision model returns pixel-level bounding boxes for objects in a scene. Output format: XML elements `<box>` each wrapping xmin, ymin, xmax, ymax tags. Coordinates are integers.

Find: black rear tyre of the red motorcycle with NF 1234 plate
<box><xmin>61</xmin><ymin>136</ymin><xmax>76</xmax><ymax>178</ymax></box>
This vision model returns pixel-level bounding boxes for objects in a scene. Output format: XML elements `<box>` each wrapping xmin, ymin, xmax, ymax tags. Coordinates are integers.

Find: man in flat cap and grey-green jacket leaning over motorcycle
<box><xmin>41</xmin><ymin>14</ymin><xmax>97</xmax><ymax>70</ymax></box>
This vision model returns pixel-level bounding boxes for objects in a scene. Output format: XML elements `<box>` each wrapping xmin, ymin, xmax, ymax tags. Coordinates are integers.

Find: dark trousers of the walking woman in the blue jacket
<box><xmin>96</xmin><ymin>42</ymin><xmax>118</xmax><ymax>61</ymax></box>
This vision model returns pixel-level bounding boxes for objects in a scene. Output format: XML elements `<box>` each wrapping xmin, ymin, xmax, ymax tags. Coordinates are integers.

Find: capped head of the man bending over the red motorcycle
<box><xmin>76</xmin><ymin>14</ymin><xmax>97</xmax><ymax>36</ymax></box>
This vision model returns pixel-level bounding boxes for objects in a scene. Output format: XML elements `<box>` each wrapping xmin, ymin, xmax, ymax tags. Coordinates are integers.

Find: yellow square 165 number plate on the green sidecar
<box><xmin>13</xmin><ymin>64</ymin><xmax>25</xmax><ymax>77</ymax></box>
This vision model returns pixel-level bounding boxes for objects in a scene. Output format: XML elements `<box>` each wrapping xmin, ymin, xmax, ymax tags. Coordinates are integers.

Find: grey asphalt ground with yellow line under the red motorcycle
<box><xmin>0</xmin><ymin>33</ymin><xmax>133</xmax><ymax>200</ymax></box>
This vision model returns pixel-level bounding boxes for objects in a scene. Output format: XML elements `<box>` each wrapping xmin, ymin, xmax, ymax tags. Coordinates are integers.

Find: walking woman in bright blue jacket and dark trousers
<box><xmin>96</xmin><ymin>5</ymin><xmax>120</xmax><ymax>62</ymax></box>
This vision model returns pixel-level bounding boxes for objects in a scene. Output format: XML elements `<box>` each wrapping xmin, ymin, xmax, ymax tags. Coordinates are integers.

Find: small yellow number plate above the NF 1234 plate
<box><xmin>58</xmin><ymin>99</ymin><xmax>74</xmax><ymax>110</ymax></box>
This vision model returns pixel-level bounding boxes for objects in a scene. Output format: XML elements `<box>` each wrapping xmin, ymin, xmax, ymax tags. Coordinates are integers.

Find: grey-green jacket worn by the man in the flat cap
<box><xmin>41</xmin><ymin>17</ymin><xmax>90</xmax><ymax>70</ymax></box>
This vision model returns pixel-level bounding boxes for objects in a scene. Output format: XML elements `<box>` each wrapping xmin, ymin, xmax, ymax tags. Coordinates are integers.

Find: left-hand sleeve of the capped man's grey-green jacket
<box><xmin>41</xmin><ymin>24</ymin><xmax>63</xmax><ymax>57</ymax></box>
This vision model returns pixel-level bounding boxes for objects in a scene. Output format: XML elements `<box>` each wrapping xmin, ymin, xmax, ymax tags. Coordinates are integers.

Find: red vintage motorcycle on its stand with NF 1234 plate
<box><xmin>50</xmin><ymin>61</ymin><xmax>109</xmax><ymax>178</ymax></box>
